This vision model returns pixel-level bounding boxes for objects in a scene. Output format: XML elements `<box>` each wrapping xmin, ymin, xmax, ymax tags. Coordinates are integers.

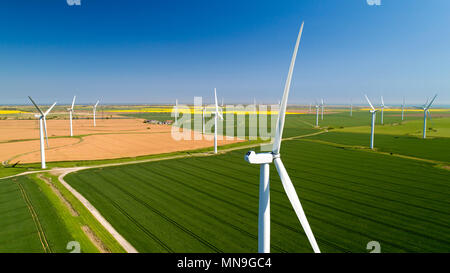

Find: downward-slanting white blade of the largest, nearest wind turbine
<box><xmin>274</xmin><ymin>157</ymin><xmax>320</xmax><ymax>253</ymax></box>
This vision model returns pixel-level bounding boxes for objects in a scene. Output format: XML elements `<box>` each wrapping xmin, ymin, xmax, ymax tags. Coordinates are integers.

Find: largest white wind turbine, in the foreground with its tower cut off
<box><xmin>245</xmin><ymin>23</ymin><xmax>320</xmax><ymax>253</ymax></box>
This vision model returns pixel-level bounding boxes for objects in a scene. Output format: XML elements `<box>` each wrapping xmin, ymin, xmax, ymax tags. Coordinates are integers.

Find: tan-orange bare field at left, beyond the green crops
<box><xmin>0</xmin><ymin>119</ymin><xmax>241</xmax><ymax>163</ymax></box>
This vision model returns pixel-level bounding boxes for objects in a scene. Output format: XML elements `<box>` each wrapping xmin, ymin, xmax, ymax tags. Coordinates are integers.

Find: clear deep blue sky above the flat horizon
<box><xmin>0</xmin><ymin>0</ymin><xmax>450</xmax><ymax>104</ymax></box>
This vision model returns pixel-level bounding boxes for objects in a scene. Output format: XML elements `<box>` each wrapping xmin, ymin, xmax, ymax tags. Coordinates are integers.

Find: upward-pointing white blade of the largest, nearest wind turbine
<box><xmin>272</xmin><ymin>22</ymin><xmax>304</xmax><ymax>154</ymax></box>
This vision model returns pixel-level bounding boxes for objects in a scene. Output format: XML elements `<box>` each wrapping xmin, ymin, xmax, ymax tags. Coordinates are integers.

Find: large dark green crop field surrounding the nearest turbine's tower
<box><xmin>65</xmin><ymin>110</ymin><xmax>450</xmax><ymax>252</ymax></box>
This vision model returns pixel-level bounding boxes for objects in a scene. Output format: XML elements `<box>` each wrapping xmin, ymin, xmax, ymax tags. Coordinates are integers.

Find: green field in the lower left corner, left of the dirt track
<box><xmin>0</xmin><ymin>173</ymin><xmax>123</xmax><ymax>253</ymax></box>
